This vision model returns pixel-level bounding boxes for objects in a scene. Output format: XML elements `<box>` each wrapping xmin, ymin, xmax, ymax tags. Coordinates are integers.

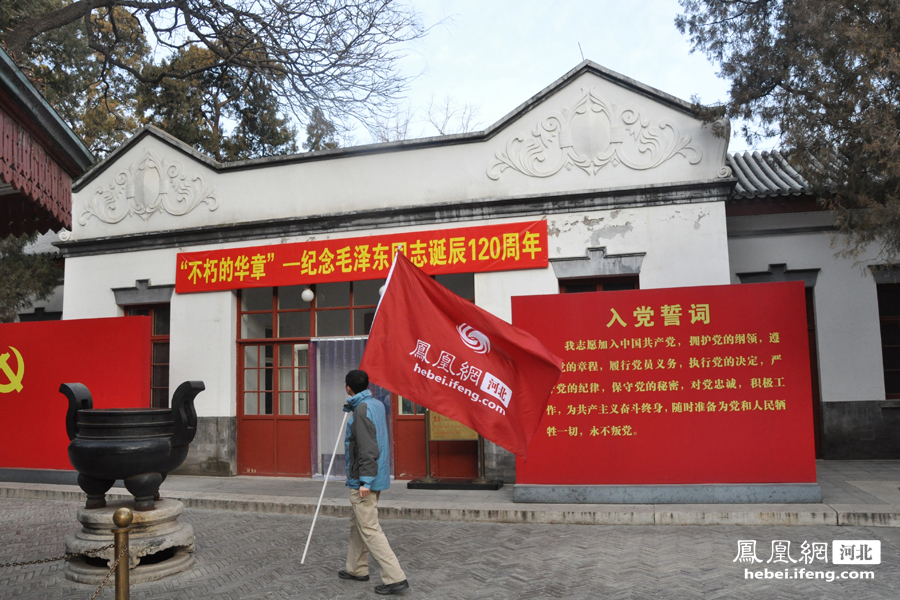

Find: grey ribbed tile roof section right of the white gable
<box><xmin>728</xmin><ymin>150</ymin><xmax>810</xmax><ymax>198</ymax></box>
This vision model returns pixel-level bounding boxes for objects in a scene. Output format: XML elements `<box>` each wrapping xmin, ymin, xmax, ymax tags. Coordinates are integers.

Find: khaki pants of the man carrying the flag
<box><xmin>347</xmin><ymin>490</ymin><xmax>406</xmax><ymax>585</ymax></box>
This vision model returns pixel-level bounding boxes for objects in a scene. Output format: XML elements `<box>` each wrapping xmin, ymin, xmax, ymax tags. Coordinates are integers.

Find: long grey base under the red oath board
<box><xmin>513</xmin><ymin>483</ymin><xmax>822</xmax><ymax>504</ymax></box>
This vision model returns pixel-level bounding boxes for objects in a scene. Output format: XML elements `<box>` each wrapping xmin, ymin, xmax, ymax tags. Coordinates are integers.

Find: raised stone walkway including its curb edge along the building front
<box><xmin>0</xmin><ymin>461</ymin><xmax>900</xmax><ymax>527</ymax></box>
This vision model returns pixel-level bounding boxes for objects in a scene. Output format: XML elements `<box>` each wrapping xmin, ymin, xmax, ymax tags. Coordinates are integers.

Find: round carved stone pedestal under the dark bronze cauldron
<box><xmin>66</xmin><ymin>500</ymin><xmax>194</xmax><ymax>585</ymax></box>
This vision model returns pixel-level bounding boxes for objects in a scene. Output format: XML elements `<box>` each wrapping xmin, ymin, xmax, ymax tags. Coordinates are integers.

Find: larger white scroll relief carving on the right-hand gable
<box><xmin>487</xmin><ymin>88</ymin><xmax>703</xmax><ymax>181</ymax></box>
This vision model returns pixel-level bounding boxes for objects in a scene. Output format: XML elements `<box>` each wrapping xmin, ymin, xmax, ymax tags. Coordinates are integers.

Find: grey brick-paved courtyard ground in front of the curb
<box><xmin>0</xmin><ymin>498</ymin><xmax>900</xmax><ymax>600</ymax></box>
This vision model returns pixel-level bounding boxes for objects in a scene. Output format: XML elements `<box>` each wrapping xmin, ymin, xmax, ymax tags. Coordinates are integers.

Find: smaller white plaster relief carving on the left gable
<box><xmin>78</xmin><ymin>150</ymin><xmax>219</xmax><ymax>225</ymax></box>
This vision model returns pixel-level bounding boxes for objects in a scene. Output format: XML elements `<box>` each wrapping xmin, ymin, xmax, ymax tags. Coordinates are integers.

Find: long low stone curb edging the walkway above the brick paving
<box><xmin>0</xmin><ymin>483</ymin><xmax>900</xmax><ymax>527</ymax></box>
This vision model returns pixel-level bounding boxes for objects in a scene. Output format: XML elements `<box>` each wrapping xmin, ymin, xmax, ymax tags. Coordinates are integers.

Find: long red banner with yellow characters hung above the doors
<box><xmin>175</xmin><ymin>221</ymin><xmax>548</xmax><ymax>294</ymax></box>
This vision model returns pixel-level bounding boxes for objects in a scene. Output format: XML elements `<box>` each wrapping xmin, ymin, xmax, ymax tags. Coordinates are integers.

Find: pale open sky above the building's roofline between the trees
<box><xmin>352</xmin><ymin>0</ymin><xmax>764</xmax><ymax>152</ymax></box>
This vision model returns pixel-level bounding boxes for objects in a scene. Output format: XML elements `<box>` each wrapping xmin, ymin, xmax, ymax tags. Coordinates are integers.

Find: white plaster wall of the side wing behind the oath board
<box><xmin>728</xmin><ymin>215</ymin><xmax>885</xmax><ymax>402</ymax></box>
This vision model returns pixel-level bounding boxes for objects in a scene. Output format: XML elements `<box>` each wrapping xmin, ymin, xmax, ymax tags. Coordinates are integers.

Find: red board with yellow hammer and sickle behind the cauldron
<box><xmin>0</xmin><ymin>317</ymin><xmax>150</xmax><ymax>469</ymax></box>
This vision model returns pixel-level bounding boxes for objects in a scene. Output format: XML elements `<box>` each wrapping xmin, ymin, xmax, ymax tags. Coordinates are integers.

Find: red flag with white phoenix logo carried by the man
<box><xmin>360</xmin><ymin>253</ymin><xmax>562</xmax><ymax>458</ymax></box>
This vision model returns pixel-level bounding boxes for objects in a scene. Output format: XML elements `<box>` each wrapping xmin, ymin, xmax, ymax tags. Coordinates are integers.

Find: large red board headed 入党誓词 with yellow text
<box><xmin>512</xmin><ymin>282</ymin><xmax>816</xmax><ymax>485</ymax></box>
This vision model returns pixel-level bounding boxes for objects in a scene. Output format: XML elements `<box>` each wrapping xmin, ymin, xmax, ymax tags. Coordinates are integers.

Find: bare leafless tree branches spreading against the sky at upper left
<box><xmin>3</xmin><ymin>0</ymin><xmax>425</xmax><ymax>127</ymax></box>
